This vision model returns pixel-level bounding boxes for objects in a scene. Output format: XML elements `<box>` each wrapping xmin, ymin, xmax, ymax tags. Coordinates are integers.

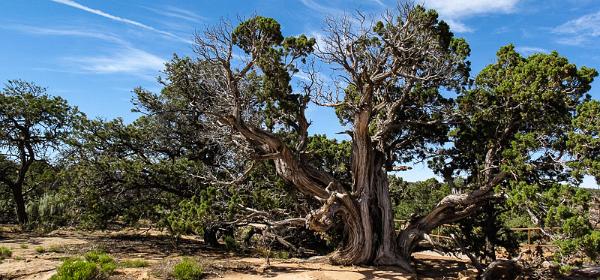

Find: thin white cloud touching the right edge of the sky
<box><xmin>552</xmin><ymin>11</ymin><xmax>600</xmax><ymax>46</ymax></box>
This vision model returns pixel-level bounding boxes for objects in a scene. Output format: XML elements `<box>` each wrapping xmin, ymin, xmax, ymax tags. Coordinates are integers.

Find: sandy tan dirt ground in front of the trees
<box><xmin>0</xmin><ymin>228</ymin><xmax>472</xmax><ymax>280</ymax></box>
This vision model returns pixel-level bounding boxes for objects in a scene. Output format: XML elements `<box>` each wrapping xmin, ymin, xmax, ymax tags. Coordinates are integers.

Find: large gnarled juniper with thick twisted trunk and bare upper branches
<box><xmin>144</xmin><ymin>5</ymin><xmax>595</xmax><ymax>269</ymax></box>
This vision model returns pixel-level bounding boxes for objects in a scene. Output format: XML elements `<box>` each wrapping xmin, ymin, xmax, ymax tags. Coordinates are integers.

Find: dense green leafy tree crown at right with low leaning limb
<box><xmin>428</xmin><ymin>45</ymin><xmax>598</xmax><ymax>268</ymax></box>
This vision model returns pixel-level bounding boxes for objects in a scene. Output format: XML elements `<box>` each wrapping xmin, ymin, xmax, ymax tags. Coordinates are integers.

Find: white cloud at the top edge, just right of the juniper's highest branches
<box><xmin>423</xmin><ymin>0</ymin><xmax>521</xmax><ymax>32</ymax></box>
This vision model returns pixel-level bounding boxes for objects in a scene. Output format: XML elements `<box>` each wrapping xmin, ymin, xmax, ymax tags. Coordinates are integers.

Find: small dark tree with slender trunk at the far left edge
<box><xmin>0</xmin><ymin>80</ymin><xmax>81</xmax><ymax>225</ymax></box>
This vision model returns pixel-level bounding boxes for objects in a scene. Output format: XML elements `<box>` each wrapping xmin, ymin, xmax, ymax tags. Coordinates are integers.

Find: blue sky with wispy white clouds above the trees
<box><xmin>0</xmin><ymin>0</ymin><xmax>600</xmax><ymax>186</ymax></box>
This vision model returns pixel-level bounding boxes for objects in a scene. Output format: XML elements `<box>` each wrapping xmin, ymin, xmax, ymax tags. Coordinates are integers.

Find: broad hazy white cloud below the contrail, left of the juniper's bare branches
<box><xmin>67</xmin><ymin>47</ymin><xmax>165</xmax><ymax>75</ymax></box>
